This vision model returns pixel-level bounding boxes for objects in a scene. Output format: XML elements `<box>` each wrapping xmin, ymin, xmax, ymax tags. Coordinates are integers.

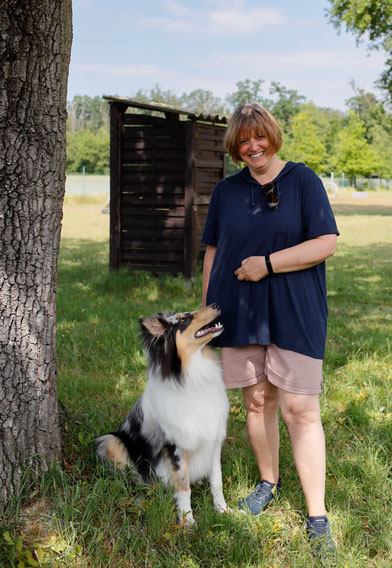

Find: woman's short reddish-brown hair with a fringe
<box><xmin>223</xmin><ymin>103</ymin><xmax>282</xmax><ymax>164</ymax></box>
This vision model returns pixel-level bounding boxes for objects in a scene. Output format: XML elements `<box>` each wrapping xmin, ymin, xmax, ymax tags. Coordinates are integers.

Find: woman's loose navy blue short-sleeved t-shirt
<box><xmin>201</xmin><ymin>162</ymin><xmax>339</xmax><ymax>359</ymax></box>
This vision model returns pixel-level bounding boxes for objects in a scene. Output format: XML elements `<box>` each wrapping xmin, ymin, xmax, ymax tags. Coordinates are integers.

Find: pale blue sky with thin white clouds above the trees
<box><xmin>68</xmin><ymin>0</ymin><xmax>384</xmax><ymax>111</ymax></box>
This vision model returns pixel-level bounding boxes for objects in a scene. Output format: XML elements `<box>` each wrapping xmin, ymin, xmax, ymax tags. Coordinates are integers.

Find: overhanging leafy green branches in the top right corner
<box><xmin>328</xmin><ymin>0</ymin><xmax>392</xmax><ymax>101</ymax></box>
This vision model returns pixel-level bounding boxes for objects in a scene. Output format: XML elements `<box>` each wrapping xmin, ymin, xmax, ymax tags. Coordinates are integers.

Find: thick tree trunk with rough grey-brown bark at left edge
<box><xmin>0</xmin><ymin>0</ymin><xmax>72</xmax><ymax>508</ymax></box>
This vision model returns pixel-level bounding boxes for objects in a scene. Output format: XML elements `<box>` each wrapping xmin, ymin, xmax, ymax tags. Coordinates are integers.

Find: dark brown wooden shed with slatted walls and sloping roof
<box><xmin>105</xmin><ymin>97</ymin><xmax>226</xmax><ymax>278</ymax></box>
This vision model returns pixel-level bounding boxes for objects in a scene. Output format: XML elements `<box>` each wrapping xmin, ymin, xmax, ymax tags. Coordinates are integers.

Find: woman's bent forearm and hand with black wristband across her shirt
<box><xmin>234</xmin><ymin>234</ymin><xmax>337</xmax><ymax>282</ymax></box>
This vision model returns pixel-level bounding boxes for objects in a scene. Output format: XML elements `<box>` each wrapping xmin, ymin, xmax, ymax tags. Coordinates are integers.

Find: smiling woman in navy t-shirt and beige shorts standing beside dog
<box><xmin>201</xmin><ymin>103</ymin><xmax>339</xmax><ymax>556</ymax></box>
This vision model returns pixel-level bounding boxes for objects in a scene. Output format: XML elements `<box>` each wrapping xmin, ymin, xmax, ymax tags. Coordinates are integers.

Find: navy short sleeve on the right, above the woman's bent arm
<box><xmin>302</xmin><ymin>169</ymin><xmax>339</xmax><ymax>240</ymax></box>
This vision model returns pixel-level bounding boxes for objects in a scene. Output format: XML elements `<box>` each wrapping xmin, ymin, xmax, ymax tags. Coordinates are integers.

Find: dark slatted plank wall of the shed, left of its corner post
<box><xmin>120</xmin><ymin>114</ymin><xmax>185</xmax><ymax>273</ymax></box>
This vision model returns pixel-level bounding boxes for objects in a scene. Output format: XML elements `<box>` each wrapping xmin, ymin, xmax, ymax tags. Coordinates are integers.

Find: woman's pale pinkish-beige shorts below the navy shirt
<box><xmin>221</xmin><ymin>343</ymin><xmax>323</xmax><ymax>394</ymax></box>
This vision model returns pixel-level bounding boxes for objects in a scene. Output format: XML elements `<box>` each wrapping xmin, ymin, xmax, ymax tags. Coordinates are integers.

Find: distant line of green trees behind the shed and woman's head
<box><xmin>67</xmin><ymin>79</ymin><xmax>392</xmax><ymax>176</ymax></box>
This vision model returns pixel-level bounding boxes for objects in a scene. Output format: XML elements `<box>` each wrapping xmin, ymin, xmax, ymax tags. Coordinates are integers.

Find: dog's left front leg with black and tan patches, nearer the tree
<box><xmin>167</xmin><ymin>445</ymin><xmax>195</xmax><ymax>527</ymax></box>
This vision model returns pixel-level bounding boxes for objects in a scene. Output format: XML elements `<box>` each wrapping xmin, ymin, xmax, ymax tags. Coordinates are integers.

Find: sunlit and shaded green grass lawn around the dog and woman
<box><xmin>0</xmin><ymin>191</ymin><xmax>392</xmax><ymax>568</ymax></box>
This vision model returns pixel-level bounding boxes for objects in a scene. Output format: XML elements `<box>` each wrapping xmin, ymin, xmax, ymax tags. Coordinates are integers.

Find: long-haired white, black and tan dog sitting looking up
<box><xmin>96</xmin><ymin>304</ymin><xmax>229</xmax><ymax>526</ymax></box>
